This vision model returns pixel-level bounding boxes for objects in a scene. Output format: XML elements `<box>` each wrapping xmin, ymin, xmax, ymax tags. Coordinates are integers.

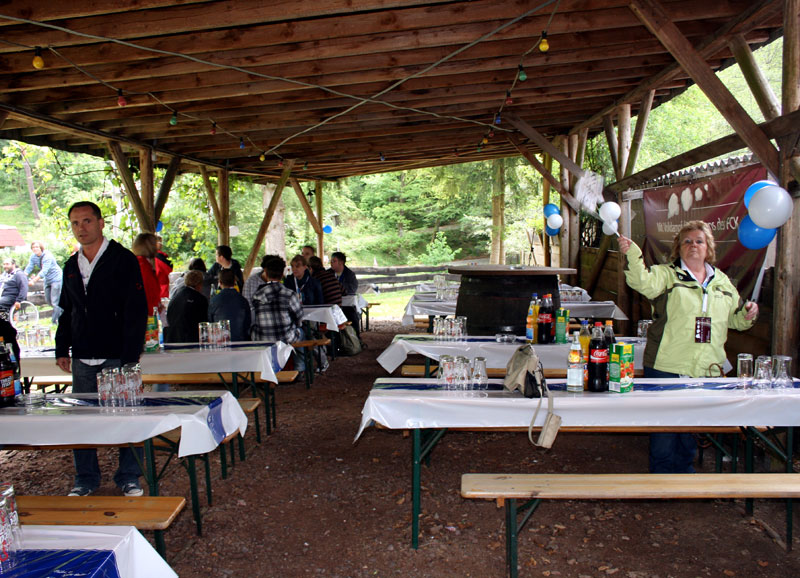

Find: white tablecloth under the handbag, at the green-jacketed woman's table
<box><xmin>356</xmin><ymin>378</ymin><xmax>800</xmax><ymax>439</ymax></box>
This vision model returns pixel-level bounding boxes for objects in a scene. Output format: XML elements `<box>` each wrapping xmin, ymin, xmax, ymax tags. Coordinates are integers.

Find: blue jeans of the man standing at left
<box><xmin>72</xmin><ymin>359</ymin><xmax>143</xmax><ymax>490</ymax></box>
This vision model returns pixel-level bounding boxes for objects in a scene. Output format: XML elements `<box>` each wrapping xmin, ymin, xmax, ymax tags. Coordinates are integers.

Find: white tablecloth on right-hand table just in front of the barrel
<box><xmin>378</xmin><ymin>334</ymin><xmax>645</xmax><ymax>373</ymax></box>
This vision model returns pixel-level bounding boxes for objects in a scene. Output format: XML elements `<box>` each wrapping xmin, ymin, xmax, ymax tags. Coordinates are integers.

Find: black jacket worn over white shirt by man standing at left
<box><xmin>56</xmin><ymin>241</ymin><xmax>147</xmax><ymax>364</ymax></box>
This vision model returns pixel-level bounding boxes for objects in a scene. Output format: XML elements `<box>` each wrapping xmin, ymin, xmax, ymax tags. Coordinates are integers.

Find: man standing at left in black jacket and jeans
<box><xmin>56</xmin><ymin>201</ymin><xmax>147</xmax><ymax>496</ymax></box>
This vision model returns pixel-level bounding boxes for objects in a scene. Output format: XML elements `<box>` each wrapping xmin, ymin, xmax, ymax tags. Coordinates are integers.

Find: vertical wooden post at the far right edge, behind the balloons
<box><xmin>772</xmin><ymin>0</ymin><xmax>800</xmax><ymax>368</ymax></box>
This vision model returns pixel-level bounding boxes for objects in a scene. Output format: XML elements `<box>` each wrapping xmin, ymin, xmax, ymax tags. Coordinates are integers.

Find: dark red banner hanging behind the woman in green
<box><xmin>643</xmin><ymin>165</ymin><xmax>767</xmax><ymax>297</ymax></box>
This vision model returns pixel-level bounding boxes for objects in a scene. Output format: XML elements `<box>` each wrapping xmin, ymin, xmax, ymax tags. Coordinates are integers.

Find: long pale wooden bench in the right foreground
<box><xmin>461</xmin><ymin>474</ymin><xmax>800</xmax><ymax>577</ymax></box>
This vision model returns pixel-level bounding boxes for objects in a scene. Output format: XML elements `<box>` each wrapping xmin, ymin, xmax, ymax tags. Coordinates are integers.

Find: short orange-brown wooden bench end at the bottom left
<box><xmin>17</xmin><ymin>496</ymin><xmax>186</xmax><ymax>558</ymax></box>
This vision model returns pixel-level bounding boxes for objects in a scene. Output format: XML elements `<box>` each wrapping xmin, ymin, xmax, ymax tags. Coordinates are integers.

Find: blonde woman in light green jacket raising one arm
<box><xmin>619</xmin><ymin>221</ymin><xmax>758</xmax><ymax>473</ymax></box>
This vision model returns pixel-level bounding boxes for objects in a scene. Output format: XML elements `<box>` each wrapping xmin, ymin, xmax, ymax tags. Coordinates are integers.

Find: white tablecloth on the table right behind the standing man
<box><xmin>21</xmin><ymin>341</ymin><xmax>293</xmax><ymax>382</ymax></box>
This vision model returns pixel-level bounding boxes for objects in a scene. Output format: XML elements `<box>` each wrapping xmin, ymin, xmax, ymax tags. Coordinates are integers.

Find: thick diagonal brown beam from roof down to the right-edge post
<box><xmin>630</xmin><ymin>0</ymin><xmax>779</xmax><ymax>175</ymax></box>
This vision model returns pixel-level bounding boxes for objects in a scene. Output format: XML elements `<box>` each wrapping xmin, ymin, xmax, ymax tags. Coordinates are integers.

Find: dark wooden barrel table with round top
<box><xmin>448</xmin><ymin>265</ymin><xmax>576</xmax><ymax>335</ymax></box>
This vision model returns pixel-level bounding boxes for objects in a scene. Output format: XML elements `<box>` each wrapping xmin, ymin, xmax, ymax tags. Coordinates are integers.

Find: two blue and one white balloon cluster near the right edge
<box><xmin>738</xmin><ymin>181</ymin><xmax>792</xmax><ymax>250</ymax></box>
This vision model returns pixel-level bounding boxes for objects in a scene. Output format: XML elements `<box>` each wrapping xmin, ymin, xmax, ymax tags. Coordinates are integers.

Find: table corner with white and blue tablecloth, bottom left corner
<box><xmin>11</xmin><ymin>524</ymin><xmax>178</xmax><ymax>578</ymax></box>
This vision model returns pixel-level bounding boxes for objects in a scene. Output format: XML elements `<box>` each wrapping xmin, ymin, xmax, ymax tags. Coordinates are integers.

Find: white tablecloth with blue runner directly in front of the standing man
<box><xmin>0</xmin><ymin>391</ymin><xmax>247</xmax><ymax>457</ymax></box>
